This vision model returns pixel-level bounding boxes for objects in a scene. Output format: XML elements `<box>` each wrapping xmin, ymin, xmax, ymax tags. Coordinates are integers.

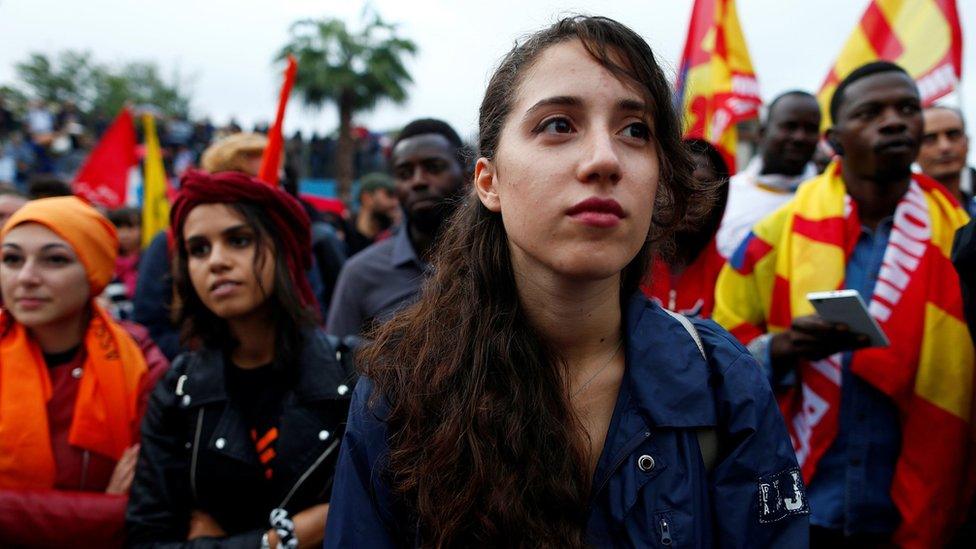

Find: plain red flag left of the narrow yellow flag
<box><xmin>71</xmin><ymin>107</ymin><xmax>138</xmax><ymax>208</ymax></box>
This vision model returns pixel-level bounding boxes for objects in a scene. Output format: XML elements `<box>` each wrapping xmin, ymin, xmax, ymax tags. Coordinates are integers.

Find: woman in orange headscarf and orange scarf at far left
<box><xmin>0</xmin><ymin>197</ymin><xmax>168</xmax><ymax>547</ymax></box>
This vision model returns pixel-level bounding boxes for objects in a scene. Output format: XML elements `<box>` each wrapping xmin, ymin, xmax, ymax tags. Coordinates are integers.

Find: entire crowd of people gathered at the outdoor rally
<box><xmin>0</xmin><ymin>12</ymin><xmax>976</xmax><ymax>549</ymax></box>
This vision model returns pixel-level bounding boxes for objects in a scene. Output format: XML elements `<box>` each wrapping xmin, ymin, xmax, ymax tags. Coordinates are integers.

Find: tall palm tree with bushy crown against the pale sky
<box><xmin>278</xmin><ymin>13</ymin><xmax>417</xmax><ymax>201</ymax></box>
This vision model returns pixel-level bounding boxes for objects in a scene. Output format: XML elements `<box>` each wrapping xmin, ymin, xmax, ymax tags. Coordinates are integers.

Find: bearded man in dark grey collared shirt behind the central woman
<box><xmin>325</xmin><ymin>118</ymin><xmax>466</xmax><ymax>337</ymax></box>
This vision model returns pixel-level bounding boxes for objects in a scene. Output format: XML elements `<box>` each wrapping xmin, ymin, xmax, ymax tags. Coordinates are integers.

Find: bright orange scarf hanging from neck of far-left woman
<box><xmin>0</xmin><ymin>303</ymin><xmax>148</xmax><ymax>488</ymax></box>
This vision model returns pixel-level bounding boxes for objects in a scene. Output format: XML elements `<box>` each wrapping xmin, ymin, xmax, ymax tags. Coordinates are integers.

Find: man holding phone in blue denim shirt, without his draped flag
<box><xmin>715</xmin><ymin>63</ymin><xmax>962</xmax><ymax>547</ymax></box>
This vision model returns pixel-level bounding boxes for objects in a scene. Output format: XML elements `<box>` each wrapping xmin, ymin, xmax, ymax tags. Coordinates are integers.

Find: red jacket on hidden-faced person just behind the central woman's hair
<box><xmin>641</xmin><ymin>238</ymin><xmax>725</xmax><ymax>318</ymax></box>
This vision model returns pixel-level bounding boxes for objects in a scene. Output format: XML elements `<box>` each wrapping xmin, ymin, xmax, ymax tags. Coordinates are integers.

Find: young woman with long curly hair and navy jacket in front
<box><xmin>325</xmin><ymin>17</ymin><xmax>807</xmax><ymax>547</ymax></box>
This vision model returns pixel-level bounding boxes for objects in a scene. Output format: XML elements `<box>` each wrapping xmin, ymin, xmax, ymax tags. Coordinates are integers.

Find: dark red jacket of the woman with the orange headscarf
<box><xmin>0</xmin><ymin>322</ymin><xmax>169</xmax><ymax>547</ymax></box>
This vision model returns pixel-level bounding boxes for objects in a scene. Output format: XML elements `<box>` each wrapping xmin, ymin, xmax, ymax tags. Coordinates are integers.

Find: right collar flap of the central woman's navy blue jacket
<box><xmin>623</xmin><ymin>293</ymin><xmax>717</xmax><ymax>427</ymax></box>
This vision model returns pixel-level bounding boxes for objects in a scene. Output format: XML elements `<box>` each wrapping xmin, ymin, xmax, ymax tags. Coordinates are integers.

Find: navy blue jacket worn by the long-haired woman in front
<box><xmin>325</xmin><ymin>296</ymin><xmax>809</xmax><ymax>548</ymax></box>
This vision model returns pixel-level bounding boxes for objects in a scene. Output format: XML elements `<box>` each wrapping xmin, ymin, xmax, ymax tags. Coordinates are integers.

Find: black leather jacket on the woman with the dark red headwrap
<box><xmin>126</xmin><ymin>331</ymin><xmax>355</xmax><ymax>549</ymax></box>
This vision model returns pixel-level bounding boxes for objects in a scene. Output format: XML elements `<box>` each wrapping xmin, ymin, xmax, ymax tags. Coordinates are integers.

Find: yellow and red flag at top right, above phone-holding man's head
<box><xmin>817</xmin><ymin>0</ymin><xmax>962</xmax><ymax>128</ymax></box>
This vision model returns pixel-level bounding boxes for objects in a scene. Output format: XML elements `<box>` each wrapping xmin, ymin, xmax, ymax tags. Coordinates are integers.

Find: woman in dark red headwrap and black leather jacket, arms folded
<box><xmin>127</xmin><ymin>172</ymin><xmax>354</xmax><ymax>548</ymax></box>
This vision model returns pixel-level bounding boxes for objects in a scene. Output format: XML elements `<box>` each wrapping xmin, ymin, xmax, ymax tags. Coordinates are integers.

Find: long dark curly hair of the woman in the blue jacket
<box><xmin>360</xmin><ymin>16</ymin><xmax>709</xmax><ymax>547</ymax></box>
